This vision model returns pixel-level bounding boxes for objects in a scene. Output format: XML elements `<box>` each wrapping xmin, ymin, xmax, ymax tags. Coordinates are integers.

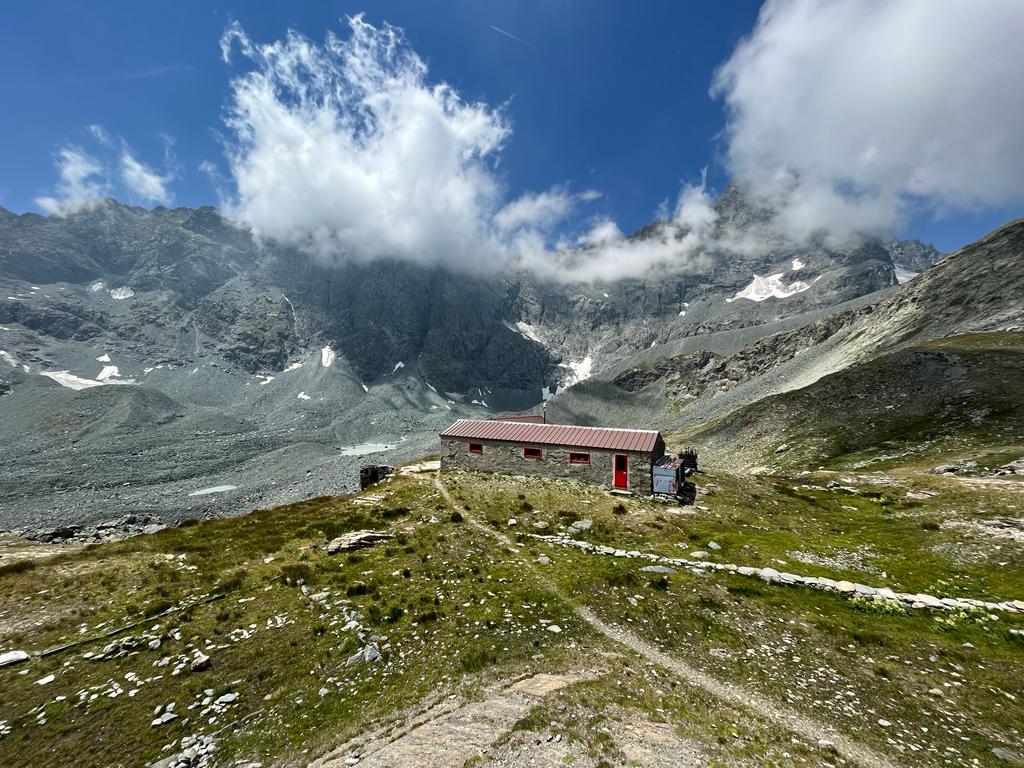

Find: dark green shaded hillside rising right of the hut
<box><xmin>687</xmin><ymin>332</ymin><xmax>1024</xmax><ymax>469</ymax></box>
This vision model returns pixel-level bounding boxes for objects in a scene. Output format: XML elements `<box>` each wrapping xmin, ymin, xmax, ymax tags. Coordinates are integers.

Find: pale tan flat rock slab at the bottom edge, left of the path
<box><xmin>310</xmin><ymin>674</ymin><xmax>590</xmax><ymax>768</ymax></box>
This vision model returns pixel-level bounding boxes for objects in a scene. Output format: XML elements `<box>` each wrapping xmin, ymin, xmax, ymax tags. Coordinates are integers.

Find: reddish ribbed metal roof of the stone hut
<box><xmin>440</xmin><ymin>419</ymin><xmax>658</xmax><ymax>453</ymax></box>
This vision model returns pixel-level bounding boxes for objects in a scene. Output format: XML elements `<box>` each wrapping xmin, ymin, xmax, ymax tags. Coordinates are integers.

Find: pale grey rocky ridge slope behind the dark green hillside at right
<box><xmin>549</xmin><ymin>219</ymin><xmax>1024</xmax><ymax>442</ymax></box>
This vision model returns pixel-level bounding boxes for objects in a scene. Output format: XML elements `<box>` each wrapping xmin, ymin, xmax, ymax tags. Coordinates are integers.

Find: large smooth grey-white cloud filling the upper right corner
<box><xmin>712</xmin><ymin>0</ymin><xmax>1024</xmax><ymax>238</ymax></box>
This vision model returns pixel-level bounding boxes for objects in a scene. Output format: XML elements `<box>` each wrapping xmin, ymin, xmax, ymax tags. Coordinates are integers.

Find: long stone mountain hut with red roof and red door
<box><xmin>440</xmin><ymin>419</ymin><xmax>665</xmax><ymax>494</ymax></box>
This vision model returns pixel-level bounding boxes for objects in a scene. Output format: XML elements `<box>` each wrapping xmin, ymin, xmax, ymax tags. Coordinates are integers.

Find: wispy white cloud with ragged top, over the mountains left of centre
<box><xmin>221</xmin><ymin>15</ymin><xmax>707</xmax><ymax>281</ymax></box>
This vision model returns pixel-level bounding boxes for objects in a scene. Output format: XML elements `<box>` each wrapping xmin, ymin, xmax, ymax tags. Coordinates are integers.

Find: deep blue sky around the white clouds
<box><xmin>0</xmin><ymin>0</ymin><xmax>1019</xmax><ymax>256</ymax></box>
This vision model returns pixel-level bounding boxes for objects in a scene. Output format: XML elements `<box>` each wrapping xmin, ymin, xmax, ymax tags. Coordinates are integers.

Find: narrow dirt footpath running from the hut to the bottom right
<box><xmin>434</xmin><ymin>476</ymin><xmax>897</xmax><ymax>768</ymax></box>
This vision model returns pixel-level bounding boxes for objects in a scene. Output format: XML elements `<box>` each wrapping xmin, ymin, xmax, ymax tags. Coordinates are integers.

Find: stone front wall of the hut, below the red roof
<box><xmin>441</xmin><ymin>438</ymin><xmax>651</xmax><ymax>495</ymax></box>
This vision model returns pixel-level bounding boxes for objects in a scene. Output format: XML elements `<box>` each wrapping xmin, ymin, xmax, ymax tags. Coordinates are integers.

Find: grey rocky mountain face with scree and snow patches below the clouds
<box><xmin>0</xmin><ymin>187</ymin><xmax>937</xmax><ymax>530</ymax></box>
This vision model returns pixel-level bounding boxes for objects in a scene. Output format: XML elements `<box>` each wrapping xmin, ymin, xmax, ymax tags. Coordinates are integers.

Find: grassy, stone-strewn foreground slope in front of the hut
<box><xmin>0</xmin><ymin>456</ymin><xmax>1024</xmax><ymax>768</ymax></box>
